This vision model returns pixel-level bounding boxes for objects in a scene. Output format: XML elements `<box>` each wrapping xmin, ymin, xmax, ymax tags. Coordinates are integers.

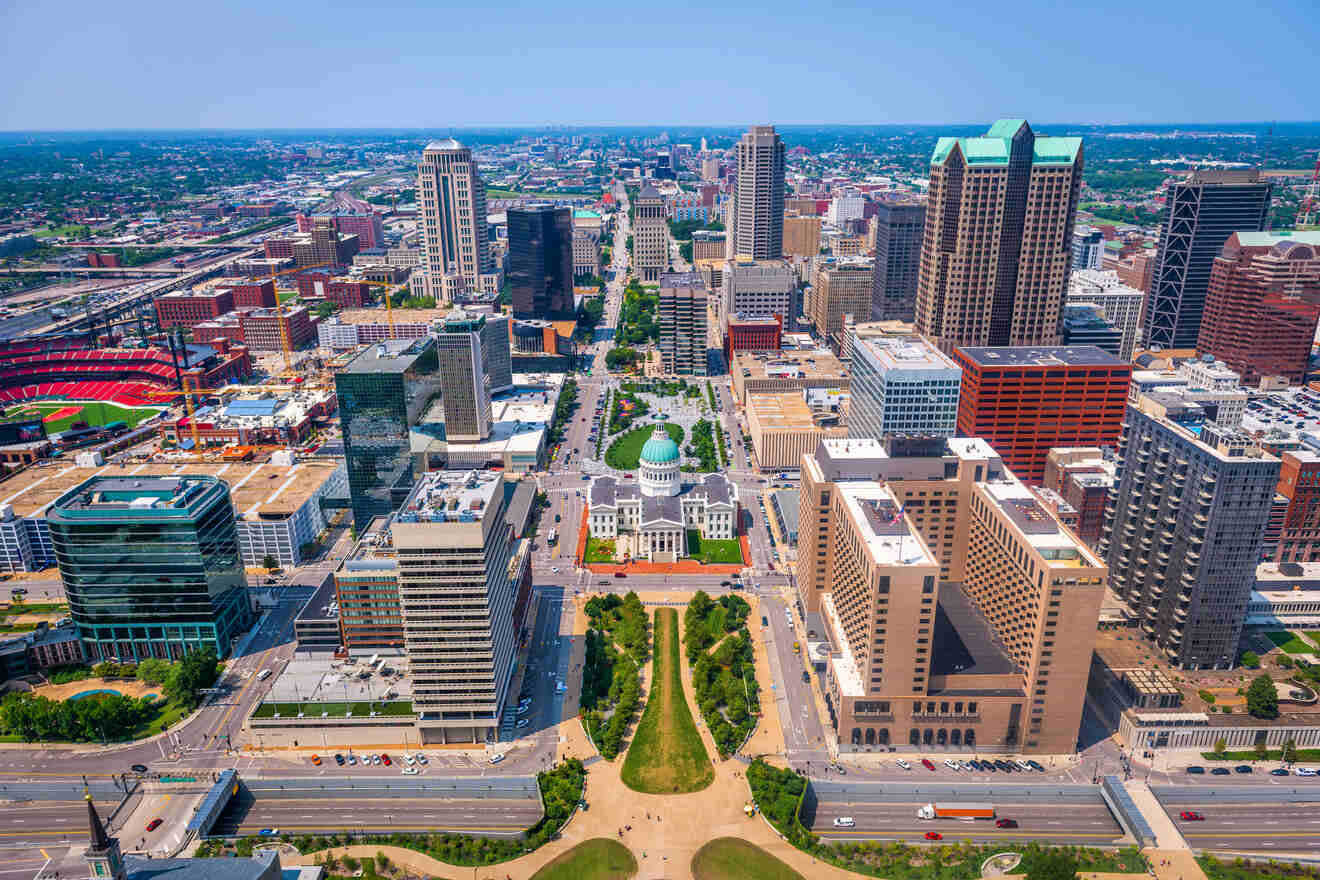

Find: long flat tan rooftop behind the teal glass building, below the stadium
<box><xmin>0</xmin><ymin>460</ymin><xmax>342</xmax><ymax>520</ymax></box>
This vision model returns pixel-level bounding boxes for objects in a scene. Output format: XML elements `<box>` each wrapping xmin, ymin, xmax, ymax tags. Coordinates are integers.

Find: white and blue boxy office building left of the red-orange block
<box><xmin>847</xmin><ymin>332</ymin><xmax>962</xmax><ymax>439</ymax></box>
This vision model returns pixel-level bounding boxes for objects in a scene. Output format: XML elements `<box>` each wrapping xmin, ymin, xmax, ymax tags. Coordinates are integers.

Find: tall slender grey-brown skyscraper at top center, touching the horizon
<box><xmin>726</xmin><ymin>125</ymin><xmax>784</xmax><ymax>260</ymax></box>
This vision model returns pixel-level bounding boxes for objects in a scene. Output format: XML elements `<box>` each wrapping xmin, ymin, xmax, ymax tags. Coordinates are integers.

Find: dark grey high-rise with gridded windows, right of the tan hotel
<box><xmin>1098</xmin><ymin>392</ymin><xmax>1279</xmax><ymax>669</ymax></box>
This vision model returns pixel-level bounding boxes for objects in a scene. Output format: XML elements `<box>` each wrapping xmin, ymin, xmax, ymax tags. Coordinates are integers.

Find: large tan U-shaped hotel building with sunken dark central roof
<box><xmin>797</xmin><ymin>437</ymin><xmax>1106</xmax><ymax>753</ymax></box>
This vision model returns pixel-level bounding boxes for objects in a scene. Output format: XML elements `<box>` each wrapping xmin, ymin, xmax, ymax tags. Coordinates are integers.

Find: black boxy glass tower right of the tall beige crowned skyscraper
<box><xmin>507</xmin><ymin>204</ymin><xmax>576</xmax><ymax>321</ymax></box>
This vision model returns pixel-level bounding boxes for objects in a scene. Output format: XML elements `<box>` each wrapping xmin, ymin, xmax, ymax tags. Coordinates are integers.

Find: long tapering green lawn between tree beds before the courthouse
<box><xmin>623</xmin><ymin>608</ymin><xmax>715</xmax><ymax>794</ymax></box>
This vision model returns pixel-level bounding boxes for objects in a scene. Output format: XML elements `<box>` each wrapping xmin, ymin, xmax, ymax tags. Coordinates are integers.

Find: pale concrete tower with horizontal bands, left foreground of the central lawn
<box><xmin>389</xmin><ymin>471</ymin><xmax>531</xmax><ymax>745</ymax></box>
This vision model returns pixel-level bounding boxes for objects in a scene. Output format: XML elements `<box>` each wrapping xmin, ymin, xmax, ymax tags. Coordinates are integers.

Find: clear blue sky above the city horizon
<box><xmin>0</xmin><ymin>0</ymin><xmax>1320</xmax><ymax>129</ymax></box>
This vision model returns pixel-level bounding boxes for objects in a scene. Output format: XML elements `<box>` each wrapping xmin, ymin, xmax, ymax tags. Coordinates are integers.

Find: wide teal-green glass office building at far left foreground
<box><xmin>46</xmin><ymin>475</ymin><xmax>252</xmax><ymax>661</ymax></box>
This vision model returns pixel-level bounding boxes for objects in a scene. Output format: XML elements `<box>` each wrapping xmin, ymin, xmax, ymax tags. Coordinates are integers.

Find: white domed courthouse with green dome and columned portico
<box><xmin>587</xmin><ymin>427</ymin><xmax>738</xmax><ymax>562</ymax></box>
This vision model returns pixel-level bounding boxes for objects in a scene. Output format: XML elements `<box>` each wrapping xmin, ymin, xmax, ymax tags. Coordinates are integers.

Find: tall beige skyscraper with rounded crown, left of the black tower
<box><xmin>417</xmin><ymin>137</ymin><xmax>495</xmax><ymax>302</ymax></box>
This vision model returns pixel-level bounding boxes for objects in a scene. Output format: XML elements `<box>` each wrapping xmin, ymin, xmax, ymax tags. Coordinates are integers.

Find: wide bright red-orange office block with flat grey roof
<box><xmin>953</xmin><ymin>346</ymin><xmax>1133</xmax><ymax>486</ymax></box>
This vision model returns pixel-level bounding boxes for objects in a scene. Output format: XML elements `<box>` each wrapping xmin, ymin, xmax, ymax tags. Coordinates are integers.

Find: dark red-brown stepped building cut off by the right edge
<box><xmin>1196</xmin><ymin>232</ymin><xmax>1320</xmax><ymax>385</ymax></box>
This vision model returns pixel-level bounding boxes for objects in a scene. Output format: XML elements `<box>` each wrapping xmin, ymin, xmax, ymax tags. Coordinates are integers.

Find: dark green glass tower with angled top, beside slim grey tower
<box><xmin>334</xmin><ymin>336</ymin><xmax>441</xmax><ymax>532</ymax></box>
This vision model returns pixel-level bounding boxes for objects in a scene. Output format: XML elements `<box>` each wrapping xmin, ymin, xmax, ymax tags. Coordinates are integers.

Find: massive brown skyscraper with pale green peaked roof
<box><xmin>916</xmin><ymin>119</ymin><xmax>1082</xmax><ymax>352</ymax></box>
